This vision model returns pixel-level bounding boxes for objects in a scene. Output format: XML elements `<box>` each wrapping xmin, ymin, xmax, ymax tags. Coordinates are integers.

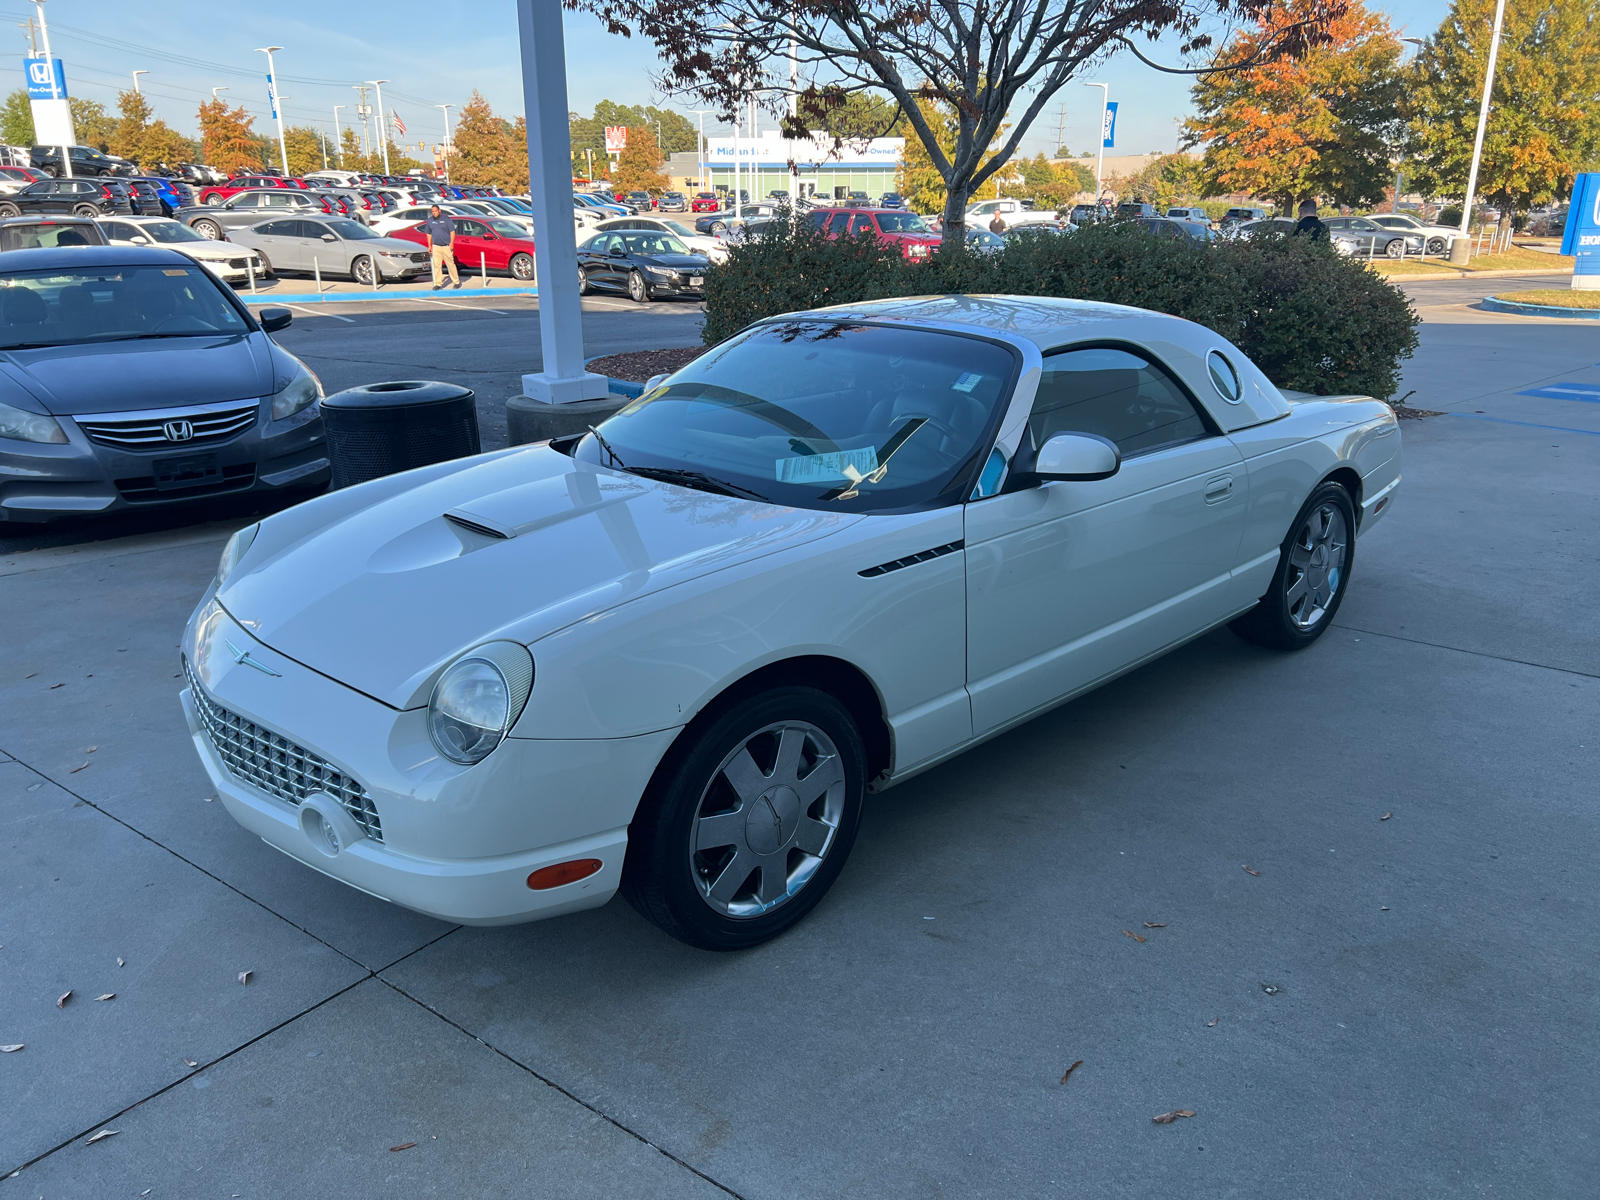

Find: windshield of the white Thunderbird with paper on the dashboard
<box><xmin>574</xmin><ymin>320</ymin><xmax>1016</xmax><ymax>512</ymax></box>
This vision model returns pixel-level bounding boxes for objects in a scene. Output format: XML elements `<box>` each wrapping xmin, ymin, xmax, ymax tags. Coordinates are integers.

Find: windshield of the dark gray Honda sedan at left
<box><xmin>0</xmin><ymin>266</ymin><xmax>250</xmax><ymax>350</ymax></box>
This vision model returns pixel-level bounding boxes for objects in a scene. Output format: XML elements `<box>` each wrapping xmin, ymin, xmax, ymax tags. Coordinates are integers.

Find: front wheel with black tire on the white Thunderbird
<box><xmin>622</xmin><ymin>685</ymin><xmax>867</xmax><ymax>950</ymax></box>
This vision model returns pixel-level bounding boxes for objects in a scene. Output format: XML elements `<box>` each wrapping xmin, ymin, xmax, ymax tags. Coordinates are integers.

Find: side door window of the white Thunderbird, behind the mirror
<box><xmin>1027</xmin><ymin>347</ymin><xmax>1206</xmax><ymax>456</ymax></box>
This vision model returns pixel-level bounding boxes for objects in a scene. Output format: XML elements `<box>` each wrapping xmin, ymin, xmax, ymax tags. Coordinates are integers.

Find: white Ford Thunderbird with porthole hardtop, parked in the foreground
<box><xmin>182</xmin><ymin>296</ymin><xmax>1400</xmax><ymax>949</ymax></box>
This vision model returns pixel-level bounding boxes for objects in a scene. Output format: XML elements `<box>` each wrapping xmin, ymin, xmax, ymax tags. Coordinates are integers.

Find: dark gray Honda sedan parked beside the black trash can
<box><xmin>0</xmin><ymin>246</ymin><xmax>330</xmax><ymax>522</ymax></box>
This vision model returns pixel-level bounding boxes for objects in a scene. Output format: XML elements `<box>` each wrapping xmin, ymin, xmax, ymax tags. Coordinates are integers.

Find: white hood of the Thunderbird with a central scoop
<box><xmin>218</xmin><ymin>446</ymin><xmax>862</xmax><ymax>709</ymax></box>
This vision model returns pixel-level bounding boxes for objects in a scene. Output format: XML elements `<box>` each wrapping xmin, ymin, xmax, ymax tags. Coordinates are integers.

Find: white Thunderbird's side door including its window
<box><xmin>966</xmin><ymin>346</ymin><xmax>1248</xmax><ymax>734</ymax></box>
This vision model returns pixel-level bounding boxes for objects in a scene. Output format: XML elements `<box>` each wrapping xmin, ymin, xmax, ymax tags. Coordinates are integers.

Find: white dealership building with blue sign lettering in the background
<box><xmin>667</xmin><ymin>130</ymin><xmax>906</xmax><ymax>200</ymax></box>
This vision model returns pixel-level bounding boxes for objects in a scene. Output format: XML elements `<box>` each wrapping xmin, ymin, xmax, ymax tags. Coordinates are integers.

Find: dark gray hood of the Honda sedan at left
<box><xmin>0</xmin><ymin>333</ymin><xmax>278</xmax><ymax>416</ymax></box>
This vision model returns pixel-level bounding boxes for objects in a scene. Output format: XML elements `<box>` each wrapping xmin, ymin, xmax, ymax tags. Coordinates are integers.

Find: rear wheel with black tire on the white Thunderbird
<box><xmin>1229</xmin><ymin>483</ymin><xmax>1355</xmax><ymax>650</ymax></box>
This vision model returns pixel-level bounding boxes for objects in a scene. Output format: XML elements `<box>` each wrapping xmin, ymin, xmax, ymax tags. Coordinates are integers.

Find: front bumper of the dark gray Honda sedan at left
<box><xmin>0</xmin><ymin>402</ymin><xmax>331</xmax><ymax>522</ymax></box>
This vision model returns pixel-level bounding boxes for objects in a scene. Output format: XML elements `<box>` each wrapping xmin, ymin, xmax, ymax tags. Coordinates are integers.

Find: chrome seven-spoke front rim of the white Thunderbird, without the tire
<box><xmin>690</xmin><ymin>722</ymin><xmax>845</xmax><ymax>917</ymax></box>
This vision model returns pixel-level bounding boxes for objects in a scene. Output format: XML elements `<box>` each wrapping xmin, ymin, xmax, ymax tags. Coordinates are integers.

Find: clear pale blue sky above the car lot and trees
<box><xmin>0</xmin><ymin>0</ymin><xmax>1448</xmax><ymax>155</ymax></box>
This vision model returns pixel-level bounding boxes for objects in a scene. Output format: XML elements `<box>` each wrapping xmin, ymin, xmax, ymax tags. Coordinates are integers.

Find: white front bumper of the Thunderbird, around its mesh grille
<box><xmin>181</xmin><ymin>600</ymin><xmax>675</xmax><ymax>925</ymax></box>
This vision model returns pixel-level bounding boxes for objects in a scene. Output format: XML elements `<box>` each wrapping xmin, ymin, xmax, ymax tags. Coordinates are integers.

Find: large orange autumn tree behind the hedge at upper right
<box><xmin>1184</xmin><ymin>0</ymin><xmax>1403</xmax><ymax>211</ymax></box>
